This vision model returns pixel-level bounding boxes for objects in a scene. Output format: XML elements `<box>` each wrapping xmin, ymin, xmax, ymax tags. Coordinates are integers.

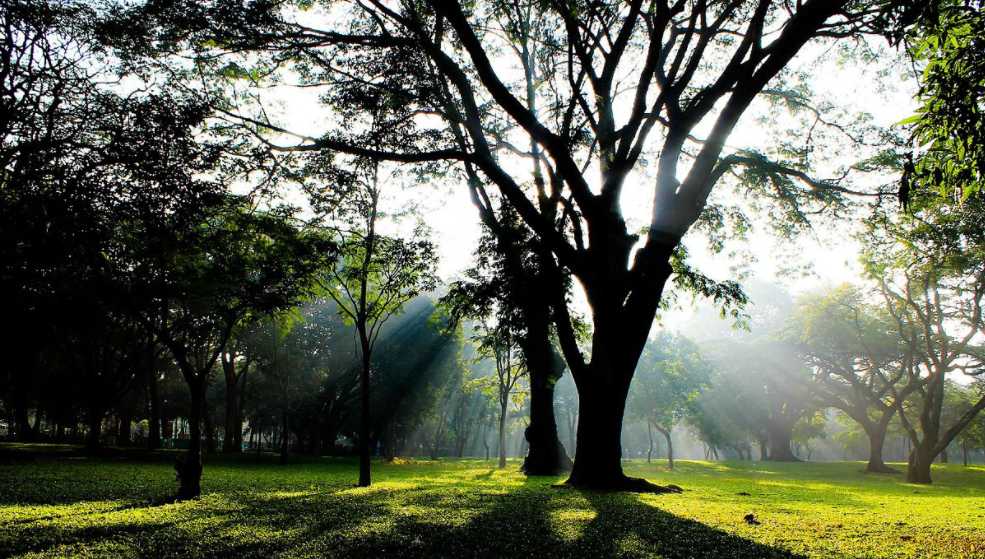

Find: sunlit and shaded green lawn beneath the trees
<box><xmin>0</xmin><ymin>445</ymin><xmax>985</xmax><ymax>558</ymax></box>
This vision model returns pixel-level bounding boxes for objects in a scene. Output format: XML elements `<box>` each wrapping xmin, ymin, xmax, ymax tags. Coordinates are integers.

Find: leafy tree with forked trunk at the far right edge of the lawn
<box><xmin>864</xmin><ymin>192</ymin><xmax>985</xmax><ymax>483</ymax></box>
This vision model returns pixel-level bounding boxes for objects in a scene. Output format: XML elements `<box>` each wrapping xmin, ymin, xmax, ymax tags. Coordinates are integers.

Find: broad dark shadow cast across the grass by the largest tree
<box><xmin>0</xmin><ymin>472</ymin><xmax>796</xmax><ymax>558</ymax></box>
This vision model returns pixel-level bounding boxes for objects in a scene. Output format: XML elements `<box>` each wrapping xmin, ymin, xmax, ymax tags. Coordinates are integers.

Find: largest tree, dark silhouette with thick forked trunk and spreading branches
<box><xmin>111</xmin><ymin>0</ymin><xmax>904</xmax><ymax>489</ymax></box>
